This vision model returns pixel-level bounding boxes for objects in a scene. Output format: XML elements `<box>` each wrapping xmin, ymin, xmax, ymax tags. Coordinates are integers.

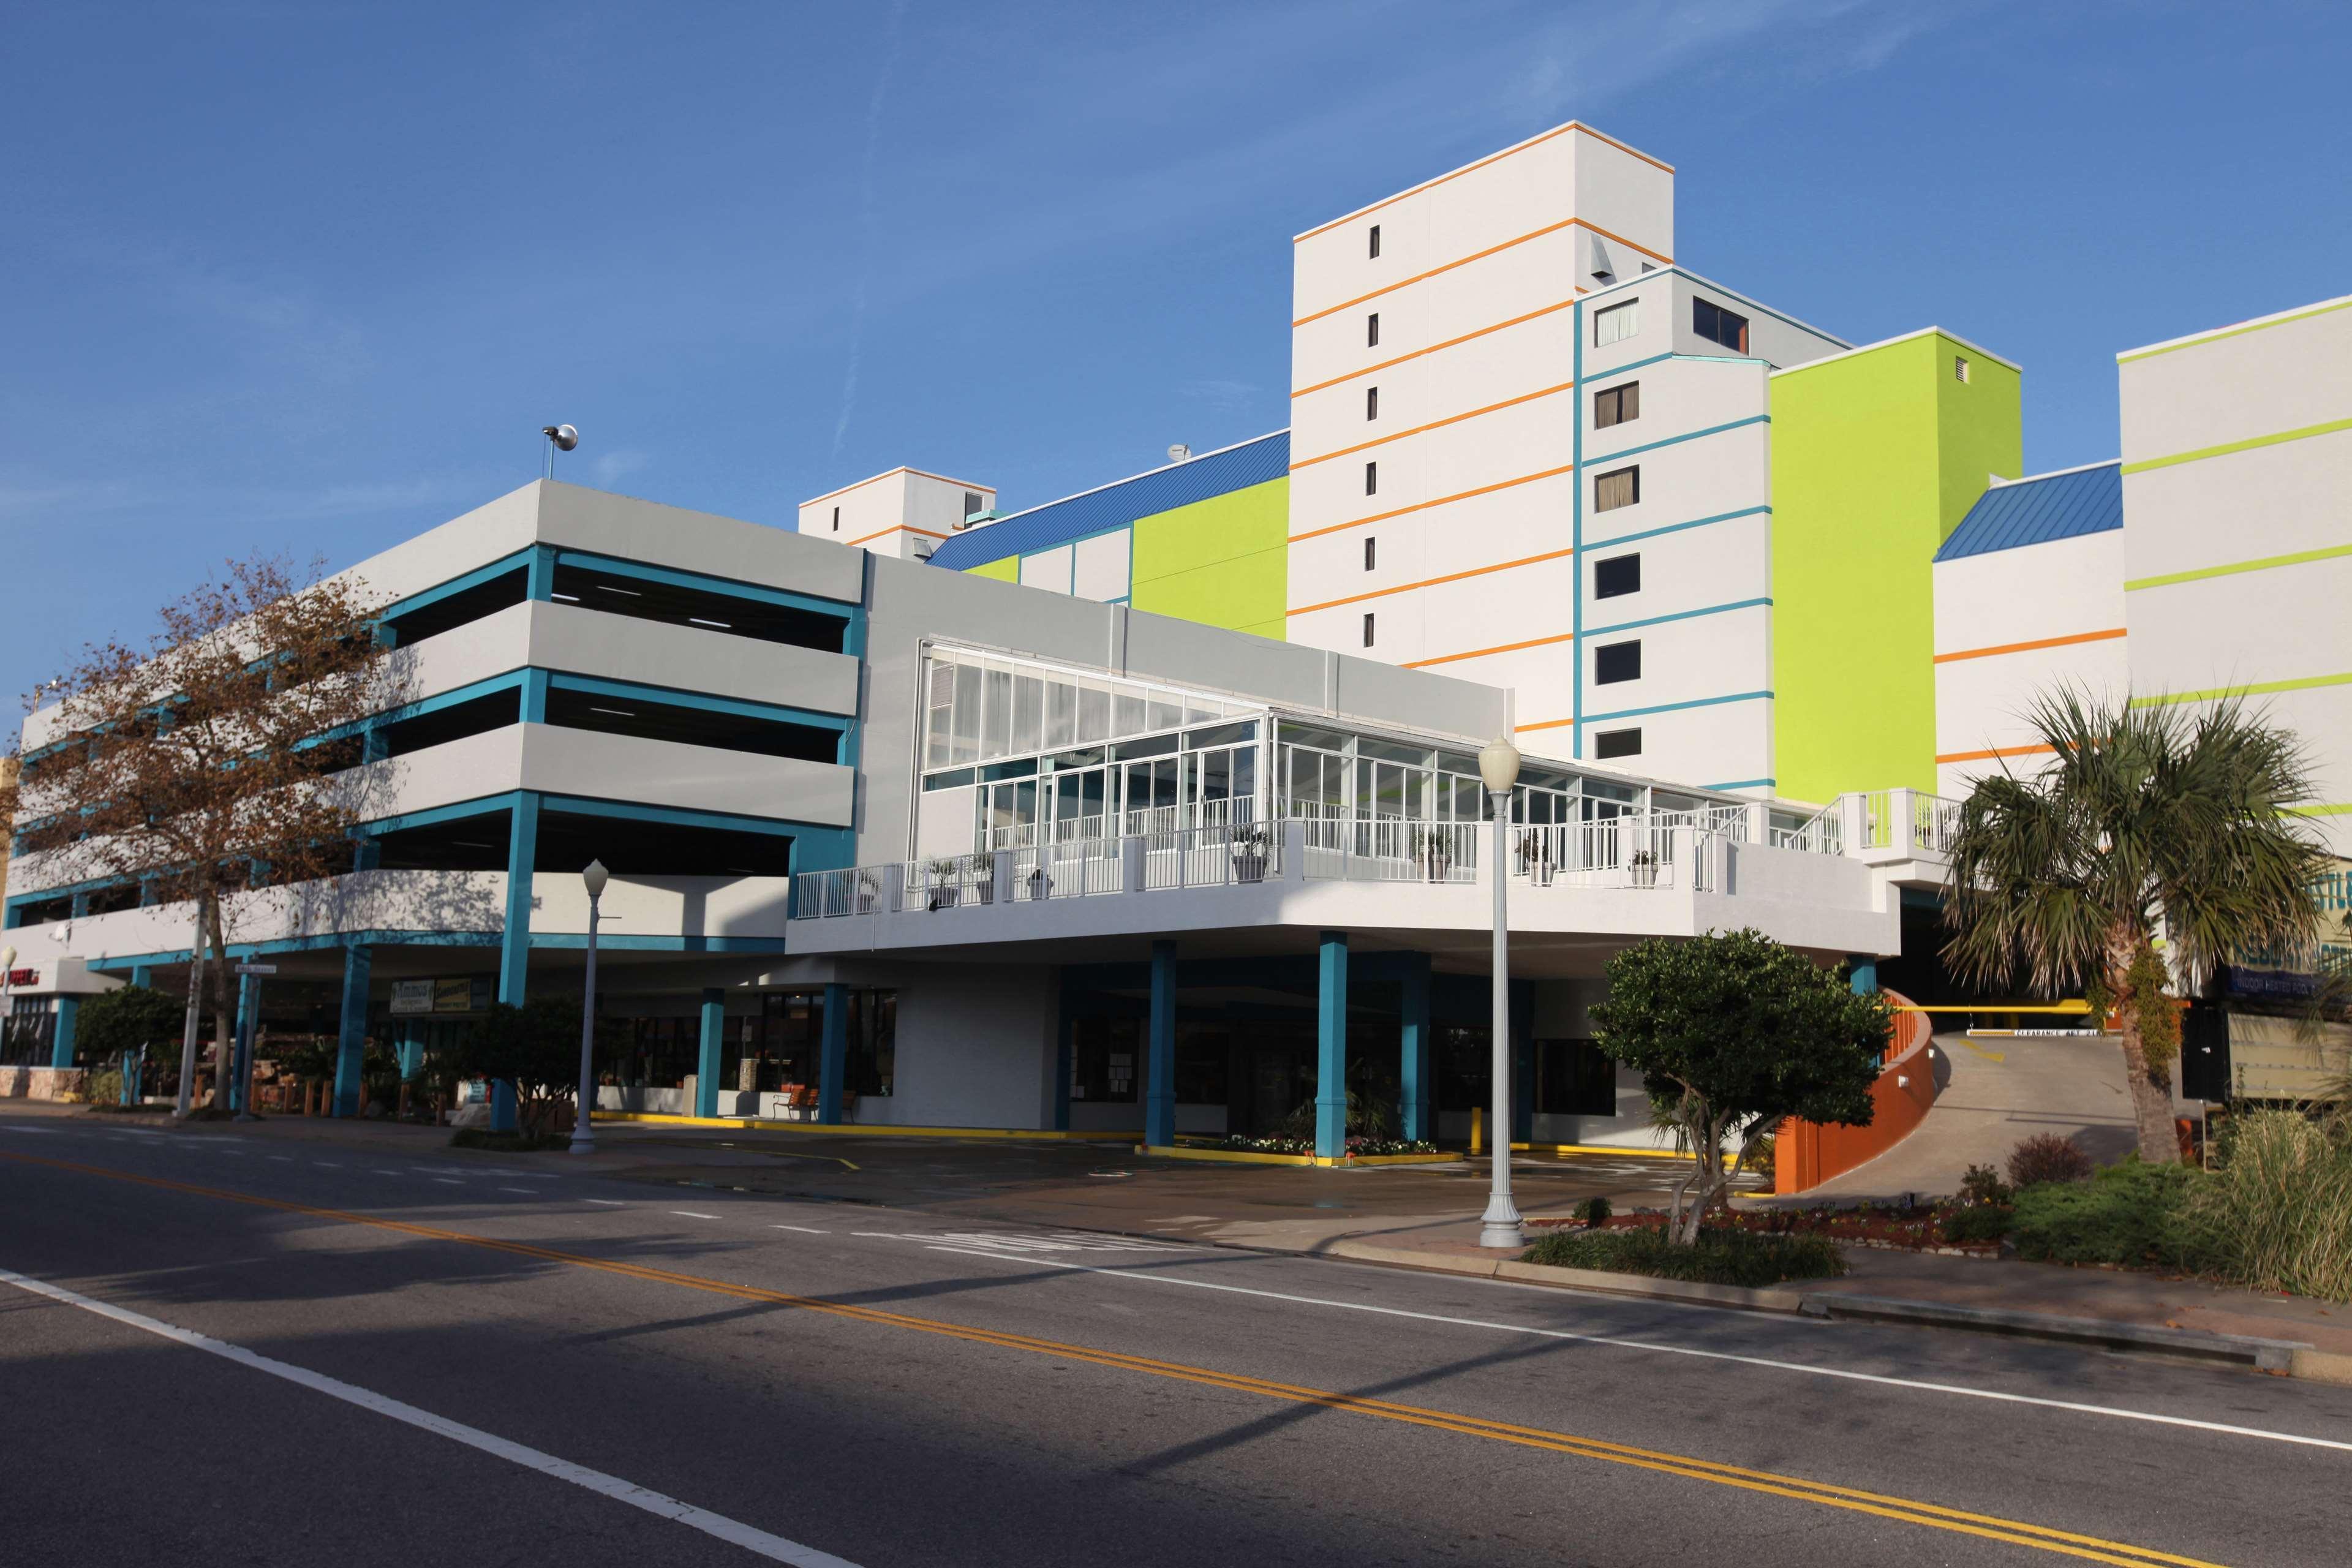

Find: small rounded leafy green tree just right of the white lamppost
<box><xmin>1593</xmin><ymin>931</ymin><xmax>1893</xmax><ymax>1246</ymax></box>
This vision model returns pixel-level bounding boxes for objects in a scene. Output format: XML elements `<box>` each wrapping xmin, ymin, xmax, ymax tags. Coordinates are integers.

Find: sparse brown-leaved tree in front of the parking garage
<box><xmin>14</xmin><ymin>555</ymin><xmax>400</xmax><ymax>1114</ymax></box>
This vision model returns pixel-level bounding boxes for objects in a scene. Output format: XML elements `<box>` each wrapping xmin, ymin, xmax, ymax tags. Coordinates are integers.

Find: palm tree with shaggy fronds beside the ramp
<box><xmin>1943</xmin><ymin>689</ymin><xmax>2329</xmax><ymax>1164</ymax></box>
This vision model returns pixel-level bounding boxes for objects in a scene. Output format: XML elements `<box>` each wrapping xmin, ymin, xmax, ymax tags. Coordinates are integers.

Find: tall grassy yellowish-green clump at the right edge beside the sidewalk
<box><xmin>2185</xmin><ymin>1110</ymin><xmax>2352</xmax><ymax>1302</ymax></box>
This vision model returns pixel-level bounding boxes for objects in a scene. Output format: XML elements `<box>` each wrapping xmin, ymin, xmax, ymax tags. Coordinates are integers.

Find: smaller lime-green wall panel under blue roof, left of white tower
<box><xmin>1126</xmin><ymin>477</ymin><xmax>1291</xmax><ymax>639</ymax></box>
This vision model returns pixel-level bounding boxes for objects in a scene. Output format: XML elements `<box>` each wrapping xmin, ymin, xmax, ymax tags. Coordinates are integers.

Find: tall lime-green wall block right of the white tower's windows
<box><xmin>1771</xmin><ymin>334</ymin><xmax>2025</xmax><ymax>802</ymax></box>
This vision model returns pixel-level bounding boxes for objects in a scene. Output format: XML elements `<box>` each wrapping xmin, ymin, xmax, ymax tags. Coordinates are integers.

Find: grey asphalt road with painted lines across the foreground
<box><xmin>0</xmin><ymin>1117</ymin><xmax>2352</xmax><ymax>1568</ymax></box>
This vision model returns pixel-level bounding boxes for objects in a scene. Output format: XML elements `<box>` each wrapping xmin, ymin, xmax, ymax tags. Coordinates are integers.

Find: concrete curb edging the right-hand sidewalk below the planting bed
<box><xmin>1322</xmin><ymin>1239</ymin><xmax>2352</xmax><ymax>1387</ymax></box>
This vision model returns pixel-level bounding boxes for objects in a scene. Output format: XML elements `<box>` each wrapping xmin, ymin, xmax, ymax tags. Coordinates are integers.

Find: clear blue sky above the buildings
<box><xmin>0</xmin><ymin>0</ymin><xmax>2352</xmax><ymax>689</ymax></box>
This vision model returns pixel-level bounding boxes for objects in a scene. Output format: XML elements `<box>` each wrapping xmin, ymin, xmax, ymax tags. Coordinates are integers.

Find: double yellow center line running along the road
<box><xmin>0</xmin><ymin>1152</ymin><xmax>2220</xmax><ymax>1568</ymax></box>
